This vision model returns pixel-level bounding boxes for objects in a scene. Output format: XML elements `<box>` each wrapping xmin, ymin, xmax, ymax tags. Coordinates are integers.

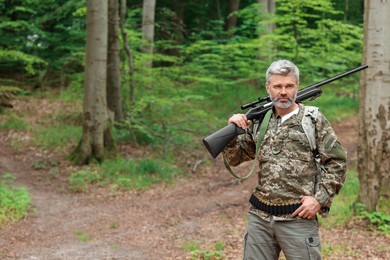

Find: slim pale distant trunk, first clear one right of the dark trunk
<box><xmin>142</xmin><ymin>0</ymin><xmax>156</xmax><ymax>67</ymax></box>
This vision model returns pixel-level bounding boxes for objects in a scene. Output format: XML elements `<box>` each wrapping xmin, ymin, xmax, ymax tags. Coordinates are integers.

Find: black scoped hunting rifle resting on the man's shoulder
<box><xmin>203</xmin><ymin>64</ymin><xmax>368</xmax><ymax>158</ymax></box>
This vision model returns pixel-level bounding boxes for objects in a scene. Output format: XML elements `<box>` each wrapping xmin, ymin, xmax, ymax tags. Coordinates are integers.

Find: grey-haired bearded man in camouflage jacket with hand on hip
<box><xmin>223</xmin><ymin>60</ymin><xmax>346</xmax><ymax>259</ymax></box>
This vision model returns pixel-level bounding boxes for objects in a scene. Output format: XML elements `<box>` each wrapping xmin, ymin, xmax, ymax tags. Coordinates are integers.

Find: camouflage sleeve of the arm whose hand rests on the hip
<box><xmin>314</xmin><ymin>113</ymin><xmax>347</xmax><ymax>208</ymax></box>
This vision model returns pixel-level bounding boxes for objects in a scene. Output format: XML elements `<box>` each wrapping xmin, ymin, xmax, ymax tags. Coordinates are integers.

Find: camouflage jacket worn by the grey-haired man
<box><xmin>223</xmin><ymin>104</ymin><xmax>346</xmax><ymax>220</ymax></box>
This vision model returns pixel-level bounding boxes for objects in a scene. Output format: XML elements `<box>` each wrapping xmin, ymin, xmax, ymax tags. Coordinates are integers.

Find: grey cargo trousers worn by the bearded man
<box><xmin>244</xmin><ymin>213</ymin><xmax>321</xmax><ymax>260</ymax></box>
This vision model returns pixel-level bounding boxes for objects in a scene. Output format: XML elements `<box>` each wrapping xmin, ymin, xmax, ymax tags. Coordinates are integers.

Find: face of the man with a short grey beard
<box><xmin>266</xmin><ymin>75</ymin><xmax>298</xmax><ymax>108</ymax></box>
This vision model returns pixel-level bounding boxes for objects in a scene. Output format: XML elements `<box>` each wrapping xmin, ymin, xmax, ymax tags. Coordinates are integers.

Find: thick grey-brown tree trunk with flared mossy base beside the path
<box><xmin>72</xmin><ymin>0</ymin><xmax>113</xmax><ymax>164</ymax></box>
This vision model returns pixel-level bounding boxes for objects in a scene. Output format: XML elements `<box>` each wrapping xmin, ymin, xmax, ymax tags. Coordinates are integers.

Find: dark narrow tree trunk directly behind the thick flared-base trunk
<box><xmin>107</xmin><ymin>0</ymin><xmax>123</xmax><ymax>121</ymax></box>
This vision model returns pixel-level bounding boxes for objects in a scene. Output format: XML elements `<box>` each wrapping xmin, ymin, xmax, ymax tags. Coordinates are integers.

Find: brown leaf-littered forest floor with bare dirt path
<box><xmin>0</xmin><ymin>98</ymin><xmax>390</xmax><ymax>260</ymax></box>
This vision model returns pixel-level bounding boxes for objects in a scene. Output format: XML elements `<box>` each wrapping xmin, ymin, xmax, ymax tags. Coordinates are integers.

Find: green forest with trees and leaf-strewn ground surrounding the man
<box><xmin>0</xmin><ymin>0</ymin><xmax>390</xmax><ymax>259</ymax></box>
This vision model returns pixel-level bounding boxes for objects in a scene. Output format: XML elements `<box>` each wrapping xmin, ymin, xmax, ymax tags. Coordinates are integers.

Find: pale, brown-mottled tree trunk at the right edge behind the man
<box><xmin>358</xmin><ymin>0</ymin><xmax>390</xmax><ymax>211</ymax></box>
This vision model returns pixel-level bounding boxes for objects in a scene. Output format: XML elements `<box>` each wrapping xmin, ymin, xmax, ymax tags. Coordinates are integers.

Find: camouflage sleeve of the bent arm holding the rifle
<box><xmin>222</xmin><ymin>128</ymin><xmax>256</xmax><ymax>166</ymax></box>
